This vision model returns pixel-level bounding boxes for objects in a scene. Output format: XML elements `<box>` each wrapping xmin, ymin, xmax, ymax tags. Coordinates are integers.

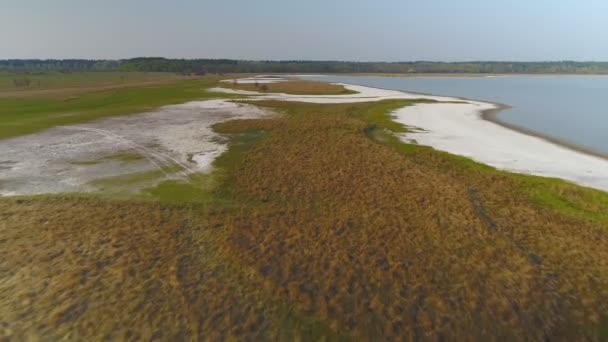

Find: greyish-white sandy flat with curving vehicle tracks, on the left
<box><xmin>0</xmin><ymin>100</ymin><xmax>269</xmax><ymax>196</ymax></box>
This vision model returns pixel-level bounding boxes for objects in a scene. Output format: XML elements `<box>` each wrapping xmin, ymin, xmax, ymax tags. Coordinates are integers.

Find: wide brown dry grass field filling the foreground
<box><xmin>0</xmin><ymin>98</ymin><xmax>608</xmax><ymax>341</ymax></box>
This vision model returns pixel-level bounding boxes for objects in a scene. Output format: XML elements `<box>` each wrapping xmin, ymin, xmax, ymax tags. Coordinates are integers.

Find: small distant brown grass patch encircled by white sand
<box><xmin>222</xmin><ymin>80</ymin><xmax>356</xmax><ymax>95</ymax></box>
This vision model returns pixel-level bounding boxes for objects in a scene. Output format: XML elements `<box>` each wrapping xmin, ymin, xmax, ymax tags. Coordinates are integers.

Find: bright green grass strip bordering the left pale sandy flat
<box><xmin>0</xmin><ymin>76</ymin><xmax>240</xmax><ymax>139</ymax></box>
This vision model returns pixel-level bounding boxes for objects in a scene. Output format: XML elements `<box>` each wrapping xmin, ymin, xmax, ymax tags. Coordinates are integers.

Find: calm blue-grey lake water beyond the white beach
<box><xmin>305</xmin><ymin>76</ymin><xmax>608</xmax><ymax>154</ymax></box>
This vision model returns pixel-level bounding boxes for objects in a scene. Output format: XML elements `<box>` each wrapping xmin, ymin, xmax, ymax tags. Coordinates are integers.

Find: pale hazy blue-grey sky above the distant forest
<box><xmin>0</xmin><ymin>0</ymin><xmax>608</xmax><ymax>61</ymax></box>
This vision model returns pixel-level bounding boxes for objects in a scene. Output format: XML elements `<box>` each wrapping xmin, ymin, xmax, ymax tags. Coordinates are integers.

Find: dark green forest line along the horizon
<box><xmin>0</xmin><ymin>57</ymin><xmax>608</xmax><ymax>74</ymax></box>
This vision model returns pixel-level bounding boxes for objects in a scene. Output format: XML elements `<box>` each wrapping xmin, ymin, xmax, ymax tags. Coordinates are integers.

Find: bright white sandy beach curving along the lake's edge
<box><xmin>214</xmin><ymin>79</ymin><xmax>608</xmax><ymax>194</ymax></box>
